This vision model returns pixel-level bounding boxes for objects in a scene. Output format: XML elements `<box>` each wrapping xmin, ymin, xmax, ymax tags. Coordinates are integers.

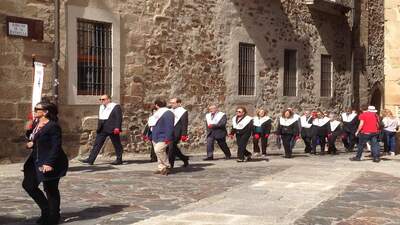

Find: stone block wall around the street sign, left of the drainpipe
<box><xmin>0</xmin><ymin>0</ymin><xmax>54</xmax><ymax>163</ymax></box>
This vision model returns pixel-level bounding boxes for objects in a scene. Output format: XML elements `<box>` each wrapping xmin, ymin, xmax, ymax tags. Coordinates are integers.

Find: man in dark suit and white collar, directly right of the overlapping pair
<box><xmin>204</xmin><ymin>105</ymin><xmax>231</xmax><ymax>160</ymax></box>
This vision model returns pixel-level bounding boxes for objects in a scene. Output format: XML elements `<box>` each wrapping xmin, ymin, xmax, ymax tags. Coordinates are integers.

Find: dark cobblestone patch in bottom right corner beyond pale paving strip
<box><xmin>295</xmin><ymin>172</ymin><xmax>400</xmax><ymax>225</ymax></box>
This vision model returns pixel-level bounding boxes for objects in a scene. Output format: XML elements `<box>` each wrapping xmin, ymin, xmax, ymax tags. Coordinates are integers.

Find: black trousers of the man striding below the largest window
<box><xmin>89</xmin><ymin>132</ymin><xmax>123</xmax><ymax>162</ymax></box>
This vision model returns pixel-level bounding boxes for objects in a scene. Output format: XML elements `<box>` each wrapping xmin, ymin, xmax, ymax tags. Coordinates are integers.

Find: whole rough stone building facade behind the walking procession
<box><xmin>0</xmin><ymin>0</ymin><xmax>383</xmax><ymax>162</ymax></box>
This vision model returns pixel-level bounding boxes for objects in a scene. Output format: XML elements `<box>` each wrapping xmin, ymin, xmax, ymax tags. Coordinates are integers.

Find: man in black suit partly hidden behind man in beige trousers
<box><xmin>168</xmin><ymin>98</ymin><xmax>189</xmax><ymax>168</ymax></box>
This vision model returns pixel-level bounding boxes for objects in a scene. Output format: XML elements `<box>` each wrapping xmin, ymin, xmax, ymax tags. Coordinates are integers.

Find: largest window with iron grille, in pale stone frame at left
<box><xmin>77</xmin><ymin>19</ymin><xmax>112</xmax><ymax>95</ymax></box>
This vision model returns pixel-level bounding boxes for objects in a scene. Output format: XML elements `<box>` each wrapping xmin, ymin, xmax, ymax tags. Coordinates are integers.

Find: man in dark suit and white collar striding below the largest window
<box><xmin>81</xmin><ymin>95</ymin><xmax>123</xmax><ymax>165</ymax></box>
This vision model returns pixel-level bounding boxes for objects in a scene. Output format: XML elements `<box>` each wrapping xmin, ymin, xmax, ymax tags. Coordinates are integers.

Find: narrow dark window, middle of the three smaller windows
<box><xmin>283</xmin><ymin>49</ymin><xmax>297</xmax><ymax>96</ymax></box>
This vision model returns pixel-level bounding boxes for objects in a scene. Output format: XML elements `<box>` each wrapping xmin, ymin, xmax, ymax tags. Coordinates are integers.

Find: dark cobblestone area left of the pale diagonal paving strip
<box><xmin>0</xmin><ymin>155</ymin><xmax>285</xmax><ymax>224</ymax></box>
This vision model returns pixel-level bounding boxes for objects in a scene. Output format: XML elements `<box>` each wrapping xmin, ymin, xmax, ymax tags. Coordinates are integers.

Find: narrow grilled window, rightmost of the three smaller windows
<box><xmin>321</xmin><ymin>55</ymin><xmax>332</xmax><ymax>97</ymax></box>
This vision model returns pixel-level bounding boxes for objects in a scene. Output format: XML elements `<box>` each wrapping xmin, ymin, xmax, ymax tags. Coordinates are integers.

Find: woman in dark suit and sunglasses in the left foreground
<box><xmin>22</xmin><ymin>102</ymin><xmax>68</xmax><ymax>225</ymax></box>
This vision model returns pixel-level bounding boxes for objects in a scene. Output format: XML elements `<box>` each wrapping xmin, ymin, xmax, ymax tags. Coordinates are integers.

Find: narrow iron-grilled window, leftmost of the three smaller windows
<box><xmin>239</xmin><ymin>43</ymin><xmax>255</xmax><ymax>95</ymax></box>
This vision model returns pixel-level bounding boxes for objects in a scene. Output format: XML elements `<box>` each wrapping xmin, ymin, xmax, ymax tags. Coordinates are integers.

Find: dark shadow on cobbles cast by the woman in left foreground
<box><xmin>60</xmin><ymin>205</ymin><xmax>129</xmax><ymax>224</ymax></box>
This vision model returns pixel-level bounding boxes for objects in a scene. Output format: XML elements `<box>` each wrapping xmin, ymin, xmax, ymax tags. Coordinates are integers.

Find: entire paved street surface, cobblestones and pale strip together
<box><xmin>0</xmin><ymin>149</ymin><xmax>400</xmax><ymax>225</ymax></box>
